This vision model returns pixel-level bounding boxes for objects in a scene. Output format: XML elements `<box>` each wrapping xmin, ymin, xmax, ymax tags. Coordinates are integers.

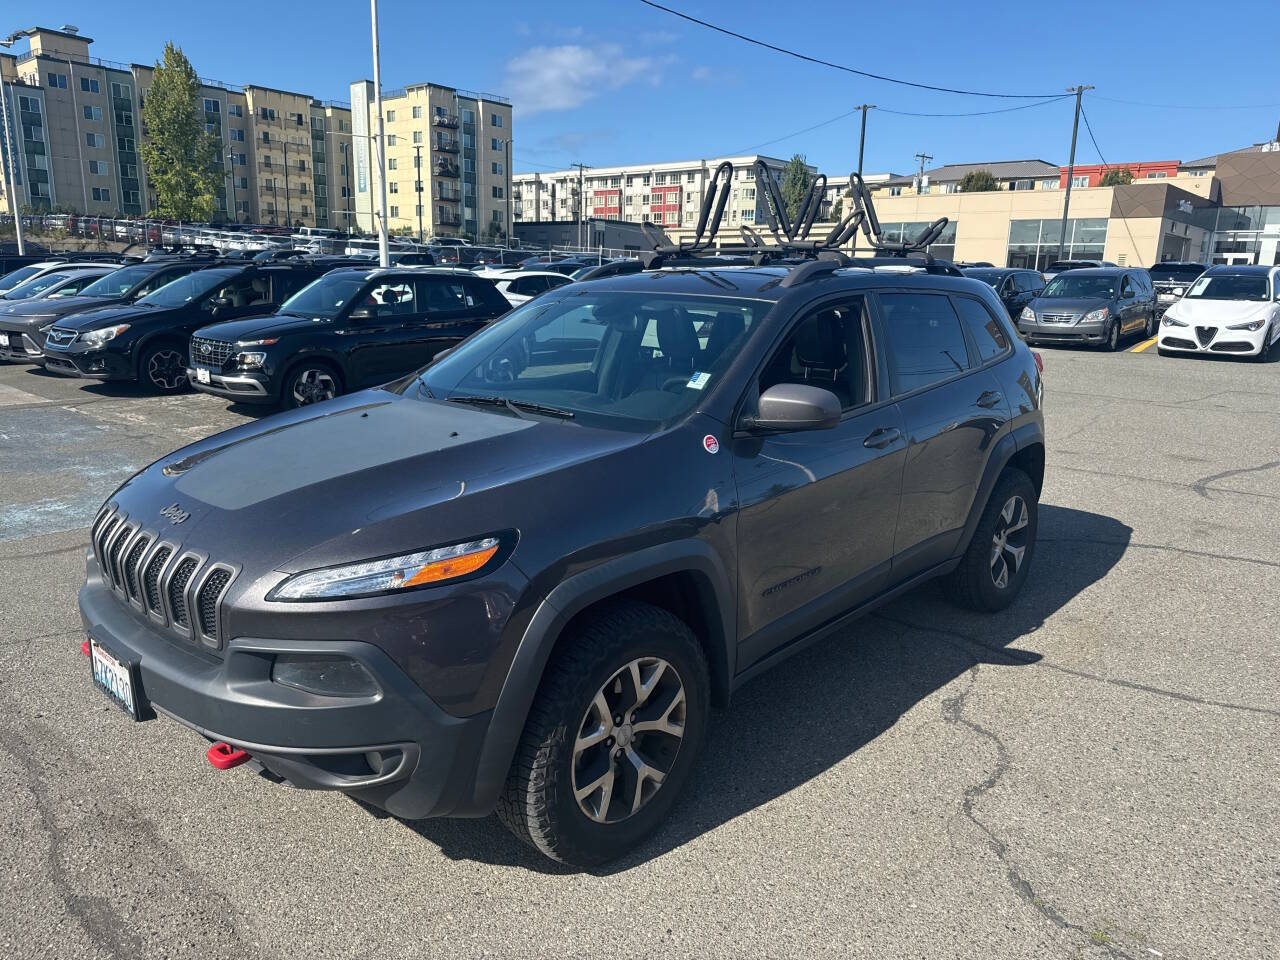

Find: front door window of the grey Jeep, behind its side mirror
<box><xmin>757</xmin><ymin>297</ymin><xmax>870</xmax><ymax>410</ymax></box>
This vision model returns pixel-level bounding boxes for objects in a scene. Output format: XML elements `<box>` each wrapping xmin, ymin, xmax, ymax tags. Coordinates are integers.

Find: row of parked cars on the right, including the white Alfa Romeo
<box><xmin>961</xmin><ymin>261</ymin><xmax>1280</xmax><ymax>360</ymax></box>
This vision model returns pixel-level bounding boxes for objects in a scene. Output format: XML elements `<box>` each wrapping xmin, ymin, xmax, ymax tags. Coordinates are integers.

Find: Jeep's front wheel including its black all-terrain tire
<box><xmin>498</xmin><ymin>602</ymin><xmax>710</xmax><ymax>868</ymax></box>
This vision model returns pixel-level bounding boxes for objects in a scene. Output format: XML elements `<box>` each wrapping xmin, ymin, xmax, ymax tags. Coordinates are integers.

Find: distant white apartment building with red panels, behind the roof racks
<box><xmin>512</xmin><ymin>154</ymin><xmax>817</xmax><ymax>232</ymax></box>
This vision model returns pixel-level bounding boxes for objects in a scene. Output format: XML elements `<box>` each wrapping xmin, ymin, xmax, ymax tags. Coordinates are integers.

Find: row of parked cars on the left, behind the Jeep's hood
<box><xmin>0</xmin><ymin>251</ymin><xmax>591</xmax><ymax>408</ymax></box>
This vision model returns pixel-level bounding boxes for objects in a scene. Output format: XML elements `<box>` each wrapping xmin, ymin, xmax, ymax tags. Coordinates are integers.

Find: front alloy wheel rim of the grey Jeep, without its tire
<box><xmin>572</xmin><ymin>657</ymin><xmax>686</xmax><ymax>823</ymax></box>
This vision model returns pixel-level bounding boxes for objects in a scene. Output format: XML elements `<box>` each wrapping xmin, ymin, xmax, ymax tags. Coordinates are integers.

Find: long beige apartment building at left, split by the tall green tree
<box><xmin>0</xmin><ymin>27</ymin><xmax>351</xmax><ymax>229</ymax></box>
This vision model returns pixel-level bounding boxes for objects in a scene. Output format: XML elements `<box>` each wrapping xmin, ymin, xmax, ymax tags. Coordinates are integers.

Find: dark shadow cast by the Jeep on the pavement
<box><xmin>396</xmin><ymin>504</ymin><xmax>1133</xmax><ymax>874</ymax></box>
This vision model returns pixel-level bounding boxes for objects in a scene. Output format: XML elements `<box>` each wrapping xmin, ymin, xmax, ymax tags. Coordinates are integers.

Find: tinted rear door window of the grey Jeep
<box><xmin>879</xmin><ymin>293</ymin><xmax>969</xmax><ymax>396</ymax></box>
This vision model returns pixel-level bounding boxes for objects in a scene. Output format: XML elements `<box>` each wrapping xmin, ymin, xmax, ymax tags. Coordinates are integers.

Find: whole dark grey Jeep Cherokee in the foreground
<box><xmin>79</xmin><ymin>260</ymin><xmax>1044</xmax><ymax>864</ymax></box>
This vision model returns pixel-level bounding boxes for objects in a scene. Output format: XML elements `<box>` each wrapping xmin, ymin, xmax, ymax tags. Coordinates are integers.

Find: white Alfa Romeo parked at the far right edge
<box><xmin>1157</xmin><ymin>266</ymin><xmax>1280</xmax><ymax>360</ymax></box>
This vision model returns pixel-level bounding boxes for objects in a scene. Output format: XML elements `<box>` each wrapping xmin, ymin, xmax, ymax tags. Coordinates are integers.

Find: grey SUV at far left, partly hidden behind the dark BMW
<box><xmin>0</xmin><ymin>257</ymin><xmax>211</xmax><ymax>364</ymax></box>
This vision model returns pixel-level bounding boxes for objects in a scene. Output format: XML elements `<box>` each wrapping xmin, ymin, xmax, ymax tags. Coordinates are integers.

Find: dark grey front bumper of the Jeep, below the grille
<box><xmin>79</xmin><ymin>553</ymin><xmax>492</xmax><ymax>818</ymax></box>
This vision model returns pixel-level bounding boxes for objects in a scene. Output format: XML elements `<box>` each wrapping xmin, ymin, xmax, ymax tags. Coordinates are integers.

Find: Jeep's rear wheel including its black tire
<box><xmin>946</xmin><ymin>467</ymin><xmax>1039</xmax><ymax>612</ymax></box>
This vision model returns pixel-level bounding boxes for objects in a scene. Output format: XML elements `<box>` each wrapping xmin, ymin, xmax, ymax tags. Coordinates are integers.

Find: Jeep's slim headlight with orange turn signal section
<box><xmin>266</xmin><ymin>536</ymin><xmax>502</xmax><ymax>600</ymax></box>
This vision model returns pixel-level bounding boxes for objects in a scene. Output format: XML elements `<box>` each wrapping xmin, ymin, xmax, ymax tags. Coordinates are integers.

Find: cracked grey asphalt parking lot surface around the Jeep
<box><xmin>0</xmin><ymin>348</ymin><xmax>1280</xmax><ymax>960</ymax></box>
